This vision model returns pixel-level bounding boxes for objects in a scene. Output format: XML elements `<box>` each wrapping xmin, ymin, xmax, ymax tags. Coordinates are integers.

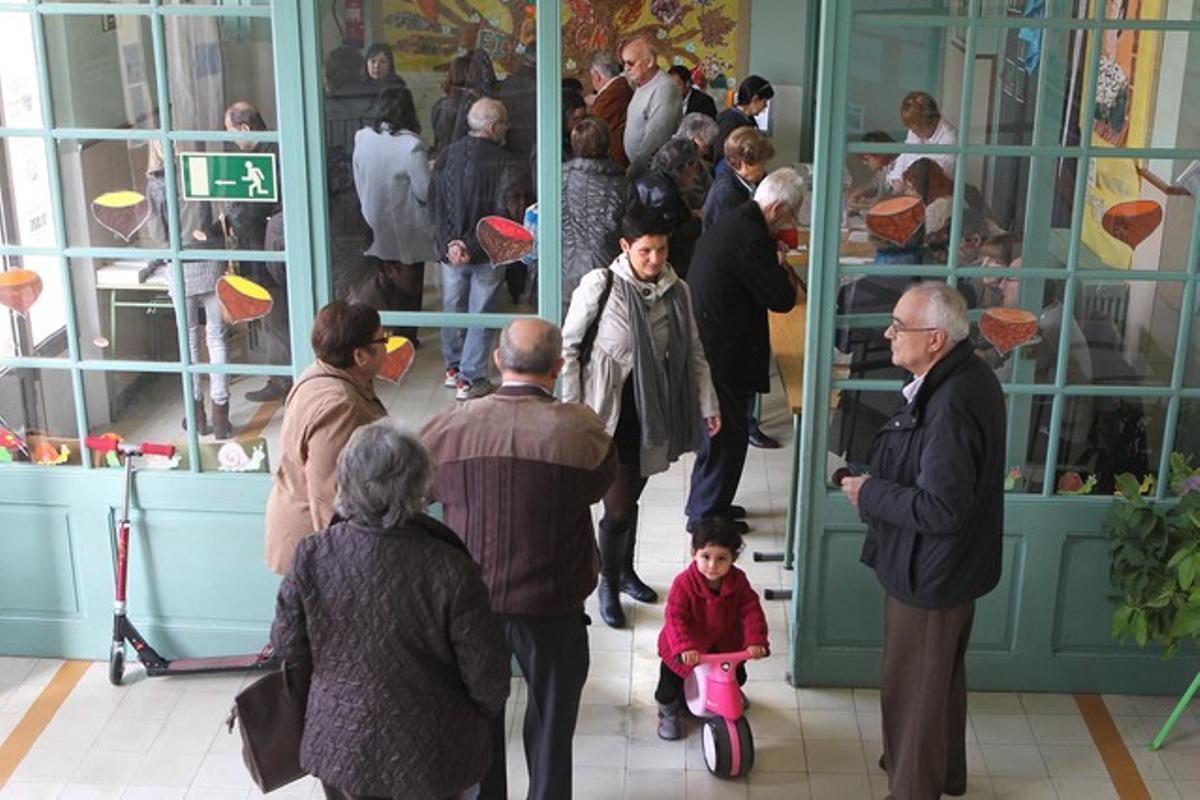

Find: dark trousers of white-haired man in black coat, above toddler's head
<box><xmin>686</xmin><ymin>375</ymin><xmax>754</xmax><ymax>522</ymax></box>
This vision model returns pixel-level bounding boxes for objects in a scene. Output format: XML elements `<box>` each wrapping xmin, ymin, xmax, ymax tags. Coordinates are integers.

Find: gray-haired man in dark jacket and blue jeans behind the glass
<box><xmin>430</xmin><ymin>97</ymin><xmax>526</xmax><ymax>399</ymax></box>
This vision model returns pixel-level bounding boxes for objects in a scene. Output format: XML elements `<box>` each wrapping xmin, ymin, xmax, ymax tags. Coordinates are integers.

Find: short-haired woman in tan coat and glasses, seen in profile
<box><xmin>266</xmin><ymin>300</ymin><xmax>388</xmax><ymax>575</ymax></box>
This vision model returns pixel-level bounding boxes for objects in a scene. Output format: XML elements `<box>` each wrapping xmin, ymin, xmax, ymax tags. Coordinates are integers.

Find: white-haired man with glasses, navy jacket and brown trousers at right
<box><xmin>841</xmin><ymin>282</ymin><xmax>1004</xmax><ymax>800</ymax></box>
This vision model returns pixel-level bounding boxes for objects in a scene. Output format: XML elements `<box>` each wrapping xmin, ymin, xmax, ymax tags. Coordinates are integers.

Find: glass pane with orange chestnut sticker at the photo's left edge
<box><xmin>0</xmin><ymin>255</ymin><xmax>68</xmax><ymax>359</ymax></box>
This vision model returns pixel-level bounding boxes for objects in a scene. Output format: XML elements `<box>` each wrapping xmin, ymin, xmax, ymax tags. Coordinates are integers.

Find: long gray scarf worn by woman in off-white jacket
<box><xmin>613</xmin><ymin>279</ymin><xmax>703</xmax><ymax>477</ymax></box>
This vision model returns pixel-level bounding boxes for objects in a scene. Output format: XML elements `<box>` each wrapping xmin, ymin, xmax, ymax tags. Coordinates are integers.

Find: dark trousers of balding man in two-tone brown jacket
<box><xmin>479</xmin><ymin>609</ymin><xmax>589</xmax><ymax>800</ymax></box>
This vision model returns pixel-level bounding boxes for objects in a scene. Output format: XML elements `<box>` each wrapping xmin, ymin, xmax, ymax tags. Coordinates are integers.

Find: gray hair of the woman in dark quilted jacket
<box><xmin>334</xmin><ymin>417</ymin><xmax>433</xmax><ymax>530</ymax></box>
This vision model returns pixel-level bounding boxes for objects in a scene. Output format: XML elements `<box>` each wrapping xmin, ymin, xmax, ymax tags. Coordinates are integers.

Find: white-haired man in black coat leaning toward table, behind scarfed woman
<box><xmin>686</xmin><ymin>167</ymin><xmax>804</xmax><ymax>533</ymax></box>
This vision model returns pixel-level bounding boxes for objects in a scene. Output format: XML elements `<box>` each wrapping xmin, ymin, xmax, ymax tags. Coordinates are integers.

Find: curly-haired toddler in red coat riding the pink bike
<box><xmin>654</xmin><ymin>518</ymin><xmax>768</xmax><ymax>739</ymax></box>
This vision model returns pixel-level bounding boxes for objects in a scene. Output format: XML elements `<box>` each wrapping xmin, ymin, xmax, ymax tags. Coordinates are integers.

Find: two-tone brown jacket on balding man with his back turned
<box><xmin>421</xmin><ymin>385</ymin><xmax>617</xmax><ymax>616</ymax></box>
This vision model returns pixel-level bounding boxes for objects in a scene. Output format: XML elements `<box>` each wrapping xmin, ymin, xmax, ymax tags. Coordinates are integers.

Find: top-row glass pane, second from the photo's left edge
<box><xmin>44</xmin><ymin>14</ymin><xmax>158</xmax><ymax>128</ymax></box>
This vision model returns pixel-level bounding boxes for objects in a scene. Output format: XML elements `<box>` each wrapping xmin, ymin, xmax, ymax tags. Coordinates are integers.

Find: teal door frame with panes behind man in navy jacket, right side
<box><xmin>788</xmin><ymin>0</ymin><xmax>1200</xmax><ymax>694</ymax></box>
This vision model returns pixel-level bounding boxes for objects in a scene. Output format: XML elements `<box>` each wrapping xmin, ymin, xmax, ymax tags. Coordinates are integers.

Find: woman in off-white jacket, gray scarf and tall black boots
<box><xmin>563</xmin><ymin>203</ymin><xmax>721</xmax><ymax>627</ymax></box>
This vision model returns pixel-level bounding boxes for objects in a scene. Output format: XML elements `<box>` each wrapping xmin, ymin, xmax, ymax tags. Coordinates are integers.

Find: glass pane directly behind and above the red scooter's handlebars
<box><xmin>84</xmin><ymin>372</ymin><xmax>188</xmax><ymax>469</ymax></box>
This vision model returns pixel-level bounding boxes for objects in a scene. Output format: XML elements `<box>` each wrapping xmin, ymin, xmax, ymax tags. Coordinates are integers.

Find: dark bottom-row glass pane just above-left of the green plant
<box><xmin>1055</xmin><ymin>397</ymin><xmax>1166</xmax><ymax>495</ymax></box>
